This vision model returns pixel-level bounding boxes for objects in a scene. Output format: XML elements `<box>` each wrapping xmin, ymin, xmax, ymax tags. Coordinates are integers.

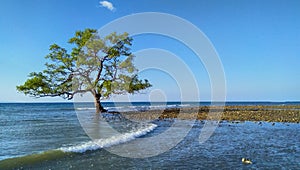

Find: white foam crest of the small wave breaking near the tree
<box><xmin>59</xmin><ymin>124</ymin><xmax>157</xmax><ymax>153</ymax></box>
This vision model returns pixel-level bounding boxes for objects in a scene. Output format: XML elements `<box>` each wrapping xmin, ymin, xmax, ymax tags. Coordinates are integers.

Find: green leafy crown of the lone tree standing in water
<box><xmin>17</xmin><ymin>29</ymin><xmax>151</xmax><ymax>100</ymax></box>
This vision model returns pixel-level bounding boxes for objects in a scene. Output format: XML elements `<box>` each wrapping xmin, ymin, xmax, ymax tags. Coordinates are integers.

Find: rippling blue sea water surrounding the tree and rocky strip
<box><xmin>0</xmin><ymin>102</ymin><xmax>300</xmax><ymax>169</ymax></box>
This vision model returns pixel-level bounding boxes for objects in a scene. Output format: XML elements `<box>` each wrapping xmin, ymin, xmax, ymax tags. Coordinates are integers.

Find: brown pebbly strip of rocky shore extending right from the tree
<box><xmin>121</xmin><ymin>105</ymin><xmax>300</xmax><ymax>123</ymax></box>
